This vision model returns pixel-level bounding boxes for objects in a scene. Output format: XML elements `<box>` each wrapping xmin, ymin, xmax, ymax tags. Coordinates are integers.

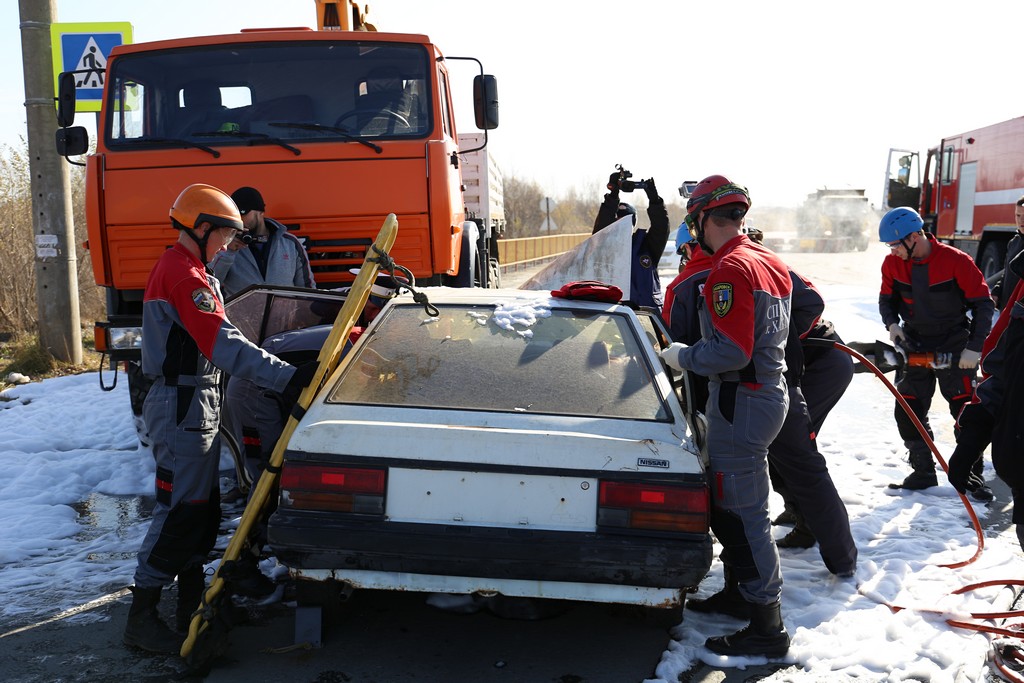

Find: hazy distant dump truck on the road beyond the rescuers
<box><xmin>797</xmin><ymin>187</ymin><xmax>873</xmax><ymax>252</ymax></box>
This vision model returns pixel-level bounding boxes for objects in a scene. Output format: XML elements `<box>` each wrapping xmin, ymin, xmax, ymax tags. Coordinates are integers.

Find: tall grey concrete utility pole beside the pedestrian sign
<box><xmin>18</xmin><ymin>0</ymin><xmax>82</xmax><ymax>365</ymax></box>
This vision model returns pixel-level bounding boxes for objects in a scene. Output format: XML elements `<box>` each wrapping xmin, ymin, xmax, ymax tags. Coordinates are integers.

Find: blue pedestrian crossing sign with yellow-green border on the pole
<box><xmin>50</xmin><ymin>22</ymin><xmax>132</xmax><ymax>112</ymax></box>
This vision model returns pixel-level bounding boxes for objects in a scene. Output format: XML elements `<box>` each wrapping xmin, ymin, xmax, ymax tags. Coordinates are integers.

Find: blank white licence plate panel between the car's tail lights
<box><xmin>385</xmin><ymin>468</ymin><xmax>598</xmax><ymax>531</ymax></box>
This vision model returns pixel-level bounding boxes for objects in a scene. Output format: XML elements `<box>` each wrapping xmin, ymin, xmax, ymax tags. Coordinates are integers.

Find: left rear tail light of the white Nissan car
<box><xmin>281</xmin><ymin>463</ymin><xmax>387</xmax><ymax>515</ymax></box>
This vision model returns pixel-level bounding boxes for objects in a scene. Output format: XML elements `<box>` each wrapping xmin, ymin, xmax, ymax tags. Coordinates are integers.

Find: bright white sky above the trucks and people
<box><xmin>0</xmin><ymin>0</ymin><xmax>1024</xmax><ymax>206</ymax></box>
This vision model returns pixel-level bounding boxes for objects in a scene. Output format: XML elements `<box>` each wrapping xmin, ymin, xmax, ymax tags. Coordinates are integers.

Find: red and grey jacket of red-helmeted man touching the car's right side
<box><xmin>679</xmin><ymin>234</ymin><xmax>793</xmax><ymax>385</ymax></box>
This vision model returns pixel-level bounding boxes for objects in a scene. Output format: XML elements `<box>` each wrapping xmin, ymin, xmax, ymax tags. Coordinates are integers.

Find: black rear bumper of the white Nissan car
<box><xmin>268</xmin><ymin>518</ymin><xmax>712</xmax><ymax>591</ymax></box>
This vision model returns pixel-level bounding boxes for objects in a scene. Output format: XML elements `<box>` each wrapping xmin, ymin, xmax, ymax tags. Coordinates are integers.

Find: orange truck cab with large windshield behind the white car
<box><xmin>56</xmin><ymin>0</ymin><xmax>498</xmax><ymax>374</ymax></box>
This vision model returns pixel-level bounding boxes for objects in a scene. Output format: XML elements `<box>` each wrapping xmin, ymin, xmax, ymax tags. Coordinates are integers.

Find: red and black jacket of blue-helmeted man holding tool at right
<box><xmin>879</xmin><ymin>234</ymin><xmax>995</xmax><ymax>352</ymax></box>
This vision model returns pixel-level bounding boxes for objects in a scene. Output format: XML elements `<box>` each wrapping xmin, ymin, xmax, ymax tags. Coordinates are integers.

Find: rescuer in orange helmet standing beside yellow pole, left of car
<box><xmin>124</xmin><ymin>184</ymin><xmax>316</xmax><ymax>654</ymax></box>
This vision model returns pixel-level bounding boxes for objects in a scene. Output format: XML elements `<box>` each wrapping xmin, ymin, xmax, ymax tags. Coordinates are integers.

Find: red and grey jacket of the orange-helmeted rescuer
<box><xmin>142</xmin><ymin>243</ymin><xmax>295</xmax><ymax>391</ymax></box>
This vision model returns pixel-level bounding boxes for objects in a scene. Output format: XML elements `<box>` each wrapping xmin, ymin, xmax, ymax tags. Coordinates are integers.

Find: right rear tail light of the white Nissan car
<box><xmin>597</xmin><ymin>481</ymin><xmax>709</xmax><ymax>533</ymax></box>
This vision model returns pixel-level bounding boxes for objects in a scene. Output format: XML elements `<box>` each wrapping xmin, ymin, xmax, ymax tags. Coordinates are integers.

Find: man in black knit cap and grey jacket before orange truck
<box><xmin>210</xmin><ymin>187</ymin><xmax>316</xmax><ymax>298</ymax></box>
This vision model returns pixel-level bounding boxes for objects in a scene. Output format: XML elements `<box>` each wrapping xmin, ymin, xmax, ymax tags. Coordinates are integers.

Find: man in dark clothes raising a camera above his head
<box><xmin>594</xmin><ymin>166</ymin><xmax>669</xmax><ymax>311</ymax></box>
